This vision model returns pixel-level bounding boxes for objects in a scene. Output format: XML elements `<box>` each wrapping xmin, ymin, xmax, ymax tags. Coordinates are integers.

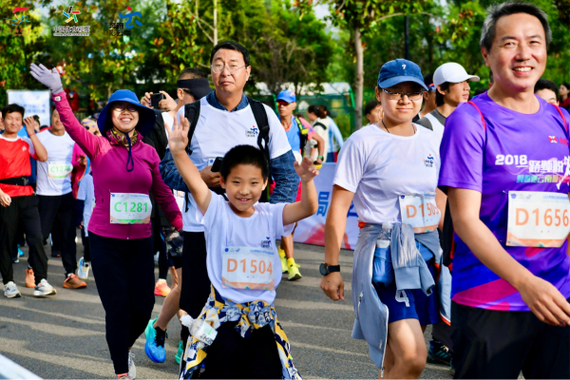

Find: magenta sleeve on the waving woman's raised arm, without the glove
<box><xmin>52</xmin><ymin>92</ymin><xmax>101</xmax><ymax>159</ymax></box>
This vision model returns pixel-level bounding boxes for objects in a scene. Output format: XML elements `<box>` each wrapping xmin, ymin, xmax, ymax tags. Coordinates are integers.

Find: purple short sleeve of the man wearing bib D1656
<box><xmin>438</xmin><ymin>103</ymin><xmax>485</xmax><ymax>193</ymax></box>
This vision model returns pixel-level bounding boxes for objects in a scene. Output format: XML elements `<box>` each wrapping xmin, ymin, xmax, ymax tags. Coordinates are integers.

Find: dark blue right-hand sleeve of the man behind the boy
<box><xmin>269</xmin><ymin>148</ymin><xmax>300</xmax><ymax>203</ymax></box>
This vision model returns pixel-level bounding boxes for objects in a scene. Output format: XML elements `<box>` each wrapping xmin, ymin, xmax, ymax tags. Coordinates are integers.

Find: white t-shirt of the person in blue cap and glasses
<box><xmin>333</xmin><ymin>124</ymin><xmax>441</xmax><ymax>224</ymax></box>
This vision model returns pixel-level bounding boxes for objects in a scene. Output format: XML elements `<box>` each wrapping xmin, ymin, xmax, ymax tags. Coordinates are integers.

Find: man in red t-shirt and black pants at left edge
<box><xmin>0</xmin><ymin>104</ymin><xmax>56</xmax><ymax>298</ymax></box>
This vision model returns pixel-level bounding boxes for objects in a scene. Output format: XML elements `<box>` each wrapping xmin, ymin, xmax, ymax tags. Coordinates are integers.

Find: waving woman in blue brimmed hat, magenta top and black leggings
<box><xmin>31</xmin><ymin>64</ymin><xmax>182</xmax><ymax>380</ymax></box>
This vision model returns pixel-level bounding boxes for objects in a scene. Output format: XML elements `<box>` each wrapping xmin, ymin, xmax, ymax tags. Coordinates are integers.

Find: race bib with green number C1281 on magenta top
<box><xmin>110</xmin><ymin>193</ymin><xmax>152</xmax><ymax>224</ymax></box>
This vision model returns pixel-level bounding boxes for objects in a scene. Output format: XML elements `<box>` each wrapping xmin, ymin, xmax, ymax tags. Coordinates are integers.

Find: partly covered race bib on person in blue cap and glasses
<box><xmin>399</xmin><ymin>193</ymin><xmax>441</xmax><ymax>234</ymax></box>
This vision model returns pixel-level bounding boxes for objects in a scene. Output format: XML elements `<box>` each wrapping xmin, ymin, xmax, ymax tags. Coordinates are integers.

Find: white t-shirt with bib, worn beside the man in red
<box><xmin>36</xmin><ymin>130</ymin><xmax>75</xmax><ymax>196</ymax></box>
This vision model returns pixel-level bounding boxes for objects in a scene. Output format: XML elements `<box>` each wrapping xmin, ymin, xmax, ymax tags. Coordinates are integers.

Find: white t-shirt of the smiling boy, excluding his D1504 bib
<box><xmin>196</xmin><ymin>192</ymin><xmax>295</xmax><ymax>304</ymax></box>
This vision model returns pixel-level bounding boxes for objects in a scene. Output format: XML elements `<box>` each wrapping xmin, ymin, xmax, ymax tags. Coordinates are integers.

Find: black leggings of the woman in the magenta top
<box><xmin>89</xmin><ymin>231</ymin><xmax>154</xmax><ymax>374</ymax></box>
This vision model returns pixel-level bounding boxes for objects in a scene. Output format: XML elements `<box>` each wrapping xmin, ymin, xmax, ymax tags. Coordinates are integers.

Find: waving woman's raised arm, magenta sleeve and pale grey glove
<box><xmin>30</xmin><ymin>63</ymin><xmax>100</xmax><ymax>159</ymax></box>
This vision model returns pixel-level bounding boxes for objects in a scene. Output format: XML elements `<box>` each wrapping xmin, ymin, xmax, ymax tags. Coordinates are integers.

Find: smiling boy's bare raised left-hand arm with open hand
<box><xmin>168</xmin><ymin>118</ymin><xmax>212</xmax><ymax>215</ymax></box>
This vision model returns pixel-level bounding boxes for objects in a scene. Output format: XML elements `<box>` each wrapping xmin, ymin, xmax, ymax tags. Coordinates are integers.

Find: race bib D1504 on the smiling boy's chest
<box><xmin>222</xmin><ymin>247</ymin><xmax>275</xmax><ymax>290</ymax></box>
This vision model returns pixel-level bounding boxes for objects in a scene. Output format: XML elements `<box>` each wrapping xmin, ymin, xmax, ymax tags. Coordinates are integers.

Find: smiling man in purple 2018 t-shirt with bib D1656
<box><xmin>439</xmin><ymin>2</ymin><xmax>570</xmax><ymax>380</ymax></box>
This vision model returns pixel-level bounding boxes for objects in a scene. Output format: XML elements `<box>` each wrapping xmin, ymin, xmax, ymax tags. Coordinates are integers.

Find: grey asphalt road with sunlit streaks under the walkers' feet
<box><xmin>0</xmin><ymin>244</ymin><xmax>452</xmax><ymax>380</ymax></box>
